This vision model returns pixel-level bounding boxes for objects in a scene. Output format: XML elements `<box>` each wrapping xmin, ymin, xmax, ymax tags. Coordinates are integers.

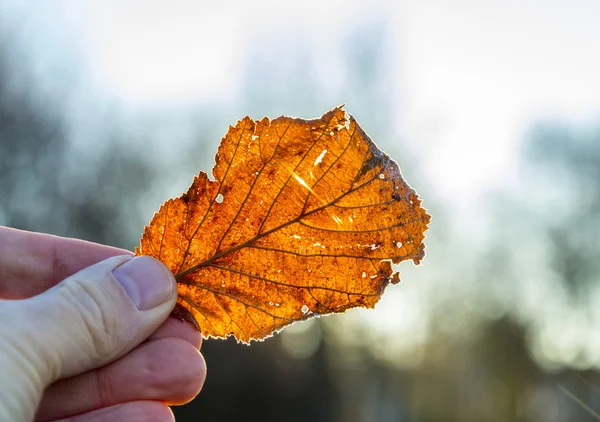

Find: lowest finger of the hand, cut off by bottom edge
<box><xmin>49</xmin><ymin>400</ymin><xmax>175</xmax><ymax>422</ymax></box>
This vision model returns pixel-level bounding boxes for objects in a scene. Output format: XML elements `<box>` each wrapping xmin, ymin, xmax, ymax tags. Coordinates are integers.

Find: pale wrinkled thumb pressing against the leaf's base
<box><xmin>0</xmin><ymin>255</ymin><xmax>177</xmax><ymax>420</ymax></box>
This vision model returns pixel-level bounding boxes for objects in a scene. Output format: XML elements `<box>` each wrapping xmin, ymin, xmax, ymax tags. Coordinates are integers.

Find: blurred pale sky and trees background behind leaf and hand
<box><xmin>0</xmin><ymin>0</ymin><xmax>600</xmax><ymax>422</ymax></box>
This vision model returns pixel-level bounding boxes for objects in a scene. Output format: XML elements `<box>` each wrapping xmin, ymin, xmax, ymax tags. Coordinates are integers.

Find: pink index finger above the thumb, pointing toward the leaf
<box><xmin>0</xmin><ymin>226</ymin><xmax>133</xmax><ymax>299</ymax></box>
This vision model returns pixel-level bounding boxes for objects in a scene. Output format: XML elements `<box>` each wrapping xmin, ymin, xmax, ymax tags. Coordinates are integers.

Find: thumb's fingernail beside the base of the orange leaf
<box><xmin>112</xmin><ymin>256</ymin><xmax>175</xmax><ymax>311</ymax></box>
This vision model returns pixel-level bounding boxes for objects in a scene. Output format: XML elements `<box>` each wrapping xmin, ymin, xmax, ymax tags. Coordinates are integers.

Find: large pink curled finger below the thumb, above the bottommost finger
<box><xmin>36</xmin><ymin>338</ymin><xmax>206</xmax><ymax>420</ymax></box>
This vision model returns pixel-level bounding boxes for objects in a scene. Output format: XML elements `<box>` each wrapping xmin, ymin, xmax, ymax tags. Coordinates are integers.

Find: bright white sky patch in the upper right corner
<box><xmin>399</xmin><ymin>0</ymin><xmax>600</xmax><ymax>204</ymax></box>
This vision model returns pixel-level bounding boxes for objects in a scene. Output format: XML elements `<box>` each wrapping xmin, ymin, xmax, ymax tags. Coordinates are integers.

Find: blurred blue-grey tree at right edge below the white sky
<box><xmin>525</xmin><ymin>123</ymin><xmax>600</xmax><ymax>298</ymax></box>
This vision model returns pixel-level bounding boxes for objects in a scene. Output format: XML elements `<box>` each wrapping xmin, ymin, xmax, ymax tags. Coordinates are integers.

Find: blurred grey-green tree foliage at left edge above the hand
<box><xmin>0</xmin><ymin>33</ymin><xmax>155</xmax><ymax>249</ymax></box>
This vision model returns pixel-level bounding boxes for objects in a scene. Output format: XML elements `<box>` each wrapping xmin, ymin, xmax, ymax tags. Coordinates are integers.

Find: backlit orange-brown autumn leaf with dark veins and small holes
<box><xmin>136</xmin><ymin>107</ymin><xmax>430</xmax><ymax>343</ymax></box>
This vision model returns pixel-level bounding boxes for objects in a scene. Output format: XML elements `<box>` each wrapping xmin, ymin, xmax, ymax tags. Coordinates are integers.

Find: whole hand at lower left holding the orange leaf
<box><xmin>0</xmin><ymin>227</ymin><xmax>206</xmax><ymax>422</ymax></box>
